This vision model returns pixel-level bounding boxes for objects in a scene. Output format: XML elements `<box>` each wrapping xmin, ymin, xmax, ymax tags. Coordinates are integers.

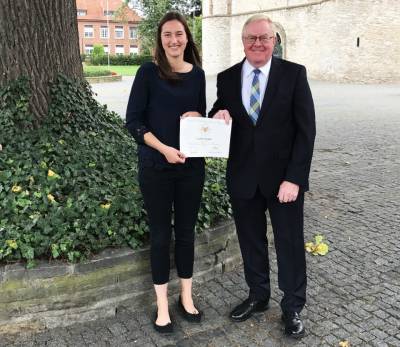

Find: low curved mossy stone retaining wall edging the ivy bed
<box><xmin>0</xmin><ymin>222</ymin><xmax>241</xmax><ymax>334</ymax></box>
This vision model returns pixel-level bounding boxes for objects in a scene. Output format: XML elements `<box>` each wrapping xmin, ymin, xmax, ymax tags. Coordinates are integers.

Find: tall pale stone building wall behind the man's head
<box><xmin>203</xmin><ymin>0</ymin><xmax>400</xmax><ymax>83</ymax></box>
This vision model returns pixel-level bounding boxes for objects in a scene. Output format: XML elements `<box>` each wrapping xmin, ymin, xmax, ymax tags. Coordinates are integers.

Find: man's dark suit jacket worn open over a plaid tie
<box><xmin>209</xmin><ymin>57</ymin><xmax>315</xmax><ymax>199</ymax></box>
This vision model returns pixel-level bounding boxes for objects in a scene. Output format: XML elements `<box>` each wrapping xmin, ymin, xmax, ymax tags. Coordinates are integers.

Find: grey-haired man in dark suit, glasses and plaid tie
<box><xmin>209</xmin><ymin>15</ymin><xmax>315</xmax><ymax>338</ymax></box>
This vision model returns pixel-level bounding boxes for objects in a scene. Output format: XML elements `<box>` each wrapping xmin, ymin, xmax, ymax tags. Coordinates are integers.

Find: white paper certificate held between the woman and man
<box><xmin>179</xmin><ymin>117</ymin><xmax>232</xmax><ymax>158</ymax></box>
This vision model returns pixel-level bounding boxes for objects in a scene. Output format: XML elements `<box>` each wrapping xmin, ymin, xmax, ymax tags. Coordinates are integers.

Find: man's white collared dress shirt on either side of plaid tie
<box><xmin>242</xmin><ymin>59</ymin><xmax>271</xmax><ymax>113</ymax></box>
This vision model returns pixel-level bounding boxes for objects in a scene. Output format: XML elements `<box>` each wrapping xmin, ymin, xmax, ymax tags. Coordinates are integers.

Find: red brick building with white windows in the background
<box><xmin>76</xmin><ymin>0</ymin><xmax>140</xmax><ymax>55</ymax></box>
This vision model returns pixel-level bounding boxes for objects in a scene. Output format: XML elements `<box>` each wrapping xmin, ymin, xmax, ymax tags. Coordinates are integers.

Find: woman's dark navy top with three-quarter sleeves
<box><xmin>126</xmin><ymin>63</ymin><xmax>206</xmax><ymax>171</ymax></box>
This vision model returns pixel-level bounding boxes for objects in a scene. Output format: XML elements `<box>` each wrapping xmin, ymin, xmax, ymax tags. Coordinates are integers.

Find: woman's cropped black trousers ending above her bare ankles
<box><xmin>139</xmin><ymin>165</ymin><xmax>204</xmax><ymax>284</ymax></box>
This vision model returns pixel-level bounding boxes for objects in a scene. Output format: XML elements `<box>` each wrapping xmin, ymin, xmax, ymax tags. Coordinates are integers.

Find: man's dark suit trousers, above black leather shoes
<box><xmin>231</xmin><ymin>189</ymin><xmax>307</xmax><ymax>312</ymax></box>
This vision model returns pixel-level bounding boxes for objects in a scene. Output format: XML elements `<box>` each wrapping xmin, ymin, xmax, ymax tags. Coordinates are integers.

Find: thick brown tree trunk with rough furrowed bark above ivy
<box><xmin>0</xmin><ymin>0</ymin><xmax>83</xmax><ymax>121</ymax></box>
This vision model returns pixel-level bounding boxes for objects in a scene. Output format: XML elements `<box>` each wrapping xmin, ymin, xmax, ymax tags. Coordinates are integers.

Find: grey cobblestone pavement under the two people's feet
<box><xmin>0</xmin><ymin>82</ymin><xmax>400</xmax><ymax>347</ymax></box>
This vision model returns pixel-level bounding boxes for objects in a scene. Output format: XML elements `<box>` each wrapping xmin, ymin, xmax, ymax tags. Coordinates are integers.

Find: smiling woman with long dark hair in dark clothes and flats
<box><xmin>126</xmin><ymin>12</ymin><xmax>206</xmax><ymax>333</ymax></box>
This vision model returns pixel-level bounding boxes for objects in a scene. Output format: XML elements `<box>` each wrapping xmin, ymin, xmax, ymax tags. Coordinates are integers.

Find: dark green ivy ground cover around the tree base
<box><xmin>0</xmin><ymin>76</ymin><xmax>231</xmax><ymax>267</ymax></box>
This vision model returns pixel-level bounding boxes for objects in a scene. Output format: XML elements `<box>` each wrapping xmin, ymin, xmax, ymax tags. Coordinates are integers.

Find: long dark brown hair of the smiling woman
<box><xmin>154</xmin><ymin>12</ymin><xmax>201</xmax><ymax>81</ymax></box>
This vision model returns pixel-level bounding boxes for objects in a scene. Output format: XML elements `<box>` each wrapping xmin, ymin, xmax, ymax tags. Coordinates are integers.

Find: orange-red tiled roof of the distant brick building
<box><xmin>76</xmin><ymin>0</ymin><xmax>141</xmax><ymax>22</ymax></box>
